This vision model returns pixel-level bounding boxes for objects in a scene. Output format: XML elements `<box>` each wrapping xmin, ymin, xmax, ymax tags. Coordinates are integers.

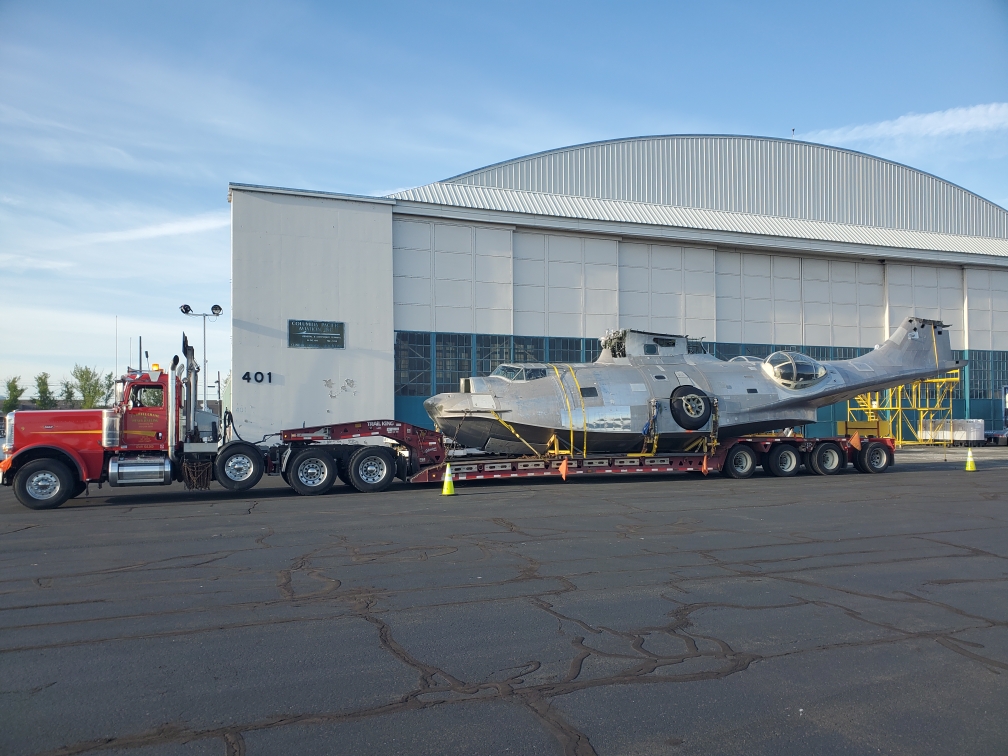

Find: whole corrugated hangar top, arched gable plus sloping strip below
<box><xmin>391</xmin><ymin>136</ymin><xmax>1008</xmax><ymax>257</ymax></box>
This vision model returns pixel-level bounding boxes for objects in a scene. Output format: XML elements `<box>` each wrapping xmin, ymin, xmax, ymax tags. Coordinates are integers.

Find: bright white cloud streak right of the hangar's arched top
<box><xmin>802</xmin><ymin>103</ymin><xmax>1008</xmax><ymax>144</ymax></box>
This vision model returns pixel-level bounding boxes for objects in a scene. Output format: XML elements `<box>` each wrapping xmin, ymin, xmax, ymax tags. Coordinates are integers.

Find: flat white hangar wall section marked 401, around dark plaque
<box><xmin>231</xmin><ymin>186</ymin><xmax>394</xmax><ymax>440</ymax></box>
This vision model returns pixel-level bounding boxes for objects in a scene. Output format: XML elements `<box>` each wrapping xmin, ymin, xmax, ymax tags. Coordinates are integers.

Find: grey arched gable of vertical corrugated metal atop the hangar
<box><xmin>421</xmin><ymin>136</ymin><xmax>1008</xmax><ymax>239</ymax></box>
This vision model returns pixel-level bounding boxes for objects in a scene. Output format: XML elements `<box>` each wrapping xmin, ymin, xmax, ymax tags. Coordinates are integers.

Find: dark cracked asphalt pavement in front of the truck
<box><xmin>0</xmin><ymin>448</ymin><xmax>1008</xmax><ymax>756</ymax></box>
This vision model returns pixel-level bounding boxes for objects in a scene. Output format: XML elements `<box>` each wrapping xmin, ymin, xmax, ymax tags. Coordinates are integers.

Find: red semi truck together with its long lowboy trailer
<box><xmin>0</xmin><ymin>337</ymin><xmax>894</xmax><ymax>509</ymax></box>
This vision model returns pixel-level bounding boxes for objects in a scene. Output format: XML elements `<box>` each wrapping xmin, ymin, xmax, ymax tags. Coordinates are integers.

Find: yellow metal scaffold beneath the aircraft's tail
<box><xmin>838</xmin><ymin>370</ymin><xmax>960</xmax><ymax>447</ymax></box>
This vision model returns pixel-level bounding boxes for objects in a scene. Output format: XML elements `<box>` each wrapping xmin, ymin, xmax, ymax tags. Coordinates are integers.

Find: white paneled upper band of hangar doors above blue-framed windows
<box><xmin>392</xmin><ymin>214</ymin><xmax>1008</xmax><ymax>350</ymax></box>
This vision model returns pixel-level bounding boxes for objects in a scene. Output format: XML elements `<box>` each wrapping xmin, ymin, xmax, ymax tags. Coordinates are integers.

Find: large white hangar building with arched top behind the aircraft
<box><xmin>229</xmin><ymin>136</ymin><xmax>1008</xmax><ymax>438</ymax></box>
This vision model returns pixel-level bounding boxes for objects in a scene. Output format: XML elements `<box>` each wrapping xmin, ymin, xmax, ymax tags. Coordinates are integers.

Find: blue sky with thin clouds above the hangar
<box><xmin>0</xmin><ymin>0</ymin><xmax>1008</xmax><ymax>391</ymax></box>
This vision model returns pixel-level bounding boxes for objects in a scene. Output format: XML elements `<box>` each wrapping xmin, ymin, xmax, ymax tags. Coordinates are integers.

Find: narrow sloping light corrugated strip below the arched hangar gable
<box><xmin>394</xmin><ymin>181</ymin><xmax>1008</xmax><ymax>257</ymax></box>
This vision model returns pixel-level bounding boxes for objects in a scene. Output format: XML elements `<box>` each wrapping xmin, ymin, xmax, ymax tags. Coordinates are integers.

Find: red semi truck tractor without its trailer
<box><xmin>0</xmin><ymin>336</ymin><xmax>265</xmax><ymax>509</ymax></box>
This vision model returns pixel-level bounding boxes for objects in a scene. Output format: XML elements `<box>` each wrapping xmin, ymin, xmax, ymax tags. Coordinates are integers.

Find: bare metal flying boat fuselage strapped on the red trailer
<box><xmin>424</xmin><ymin>318</ymin><xmax>963</xmax><ymax>455</ymax></box>
